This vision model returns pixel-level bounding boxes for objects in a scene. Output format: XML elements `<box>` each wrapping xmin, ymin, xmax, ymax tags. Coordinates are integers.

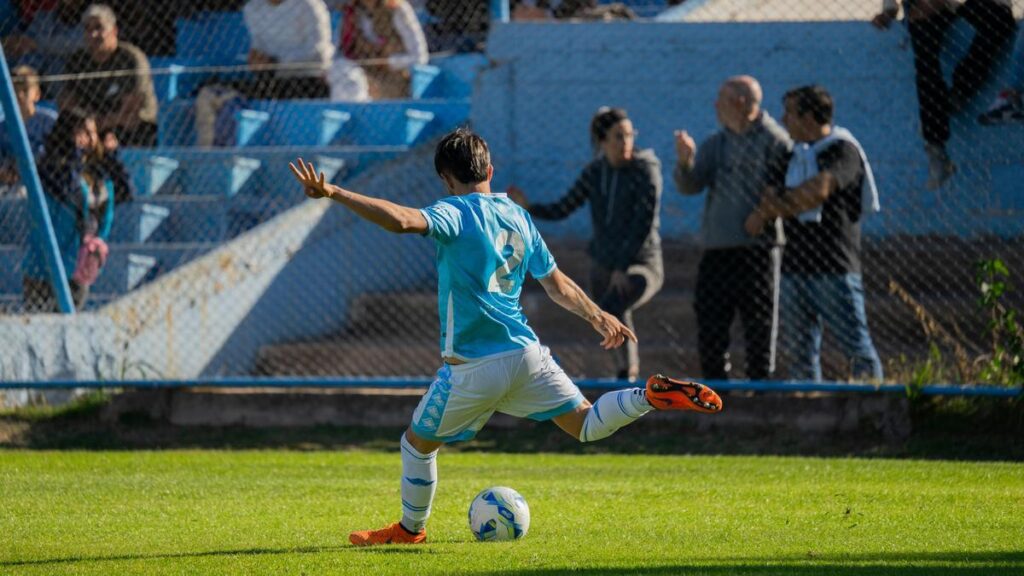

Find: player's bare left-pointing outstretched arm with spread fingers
<box><xmin>288</xmin><ymin>158</ymin><xmax>427</xmax><ymax>234</ymax></box>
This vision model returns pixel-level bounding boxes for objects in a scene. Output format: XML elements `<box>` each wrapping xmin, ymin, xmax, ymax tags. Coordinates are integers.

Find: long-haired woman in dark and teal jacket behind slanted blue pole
<box><xmin>22</xmin><ymin>109</ymin><xmax>133</xmax><ymax>312</ymax></box>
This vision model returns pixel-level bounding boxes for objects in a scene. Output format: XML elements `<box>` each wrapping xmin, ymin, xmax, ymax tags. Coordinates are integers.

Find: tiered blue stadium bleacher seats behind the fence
<box><xmin>0</xmin><ymin>2</ymin><xmax>485</xmax><ymax>310</ymax></box>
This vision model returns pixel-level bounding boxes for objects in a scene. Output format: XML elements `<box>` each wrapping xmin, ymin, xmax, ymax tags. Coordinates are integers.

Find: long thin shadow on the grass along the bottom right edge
<box><xmin>472</xmin><ymin>551</ymin><xmax>1024</xmax><ymax>576</ymax></box>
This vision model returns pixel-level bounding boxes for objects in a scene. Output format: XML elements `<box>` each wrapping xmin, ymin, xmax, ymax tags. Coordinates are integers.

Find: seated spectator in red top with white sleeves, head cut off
<box><xmin>341</xmin><ymin>0</ymin><xmax>429</xmax><ymax>99</ymax></box>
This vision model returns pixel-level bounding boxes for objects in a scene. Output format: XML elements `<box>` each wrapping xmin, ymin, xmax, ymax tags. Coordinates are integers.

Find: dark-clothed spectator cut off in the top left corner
<box><xmin>3</xmin><ymin>0</ymin><xmax>85</xmax><ymax>98</ymax></box>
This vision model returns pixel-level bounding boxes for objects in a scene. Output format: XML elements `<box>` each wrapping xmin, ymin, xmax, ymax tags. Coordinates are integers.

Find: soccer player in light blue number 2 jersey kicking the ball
<box><xmin>289</xmin><ymin>129</ymin><xmax>722</xmax><ymax>546</ymax></box>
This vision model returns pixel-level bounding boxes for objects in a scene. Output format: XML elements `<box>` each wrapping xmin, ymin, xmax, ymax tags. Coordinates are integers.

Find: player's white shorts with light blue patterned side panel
<box><xmin>412</xmin><ymin>344</ymin><xmax>584</xmax><ymax>442</ymax></box>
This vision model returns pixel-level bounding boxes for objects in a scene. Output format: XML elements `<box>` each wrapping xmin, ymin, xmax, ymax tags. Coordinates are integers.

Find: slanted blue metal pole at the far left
<box><xmin>0</xmin><ymin>45</ymin><xmax>75</xmax><ymax>314</ymax></box>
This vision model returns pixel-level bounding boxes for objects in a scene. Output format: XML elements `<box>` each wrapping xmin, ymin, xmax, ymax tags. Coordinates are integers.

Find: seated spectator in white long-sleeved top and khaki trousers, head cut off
<box><xmin>195</xmin><ymin>0</ymin><xmax>334</xmax><ymax>147</ymax></box>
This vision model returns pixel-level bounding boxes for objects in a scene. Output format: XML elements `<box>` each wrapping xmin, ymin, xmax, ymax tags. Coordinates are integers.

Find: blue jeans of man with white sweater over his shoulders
<box><xmin>780</xmin><ymin>274</ymin><xmax>882</xmax><ymax>381</ymax></box>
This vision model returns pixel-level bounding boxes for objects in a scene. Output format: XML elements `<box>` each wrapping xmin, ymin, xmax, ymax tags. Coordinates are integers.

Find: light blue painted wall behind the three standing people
<box><xmin>472</xmin><ymin>22</ymin><xmax>1024</xmax><ymax>237</ymax></box>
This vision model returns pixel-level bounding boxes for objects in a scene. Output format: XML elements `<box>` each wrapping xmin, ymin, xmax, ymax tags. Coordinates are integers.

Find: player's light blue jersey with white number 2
<box><xmin>421</xmin><ymin>193</ymin><xmax>556</xmax><ymax>360</ymax></box>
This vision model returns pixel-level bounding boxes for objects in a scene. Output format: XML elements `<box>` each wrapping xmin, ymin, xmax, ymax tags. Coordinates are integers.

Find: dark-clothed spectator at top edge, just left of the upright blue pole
<box><xmin>425</xmin><ymin>0</ymin><xmax>490</xmax><ymax>52</ymax></box>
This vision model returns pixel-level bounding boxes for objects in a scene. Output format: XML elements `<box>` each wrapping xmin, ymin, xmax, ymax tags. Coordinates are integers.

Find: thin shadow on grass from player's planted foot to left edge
<box><xmin>0</xmin><ymin>545</ymin><xmax>428</xmax><ymax>572</ymax></box>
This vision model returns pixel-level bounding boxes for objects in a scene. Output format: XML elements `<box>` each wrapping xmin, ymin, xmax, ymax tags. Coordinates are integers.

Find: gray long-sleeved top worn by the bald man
<box><xmin>673</xmin><ymin>112</ymin><xmax>793</xmax><ymax>249</ymax></box>
